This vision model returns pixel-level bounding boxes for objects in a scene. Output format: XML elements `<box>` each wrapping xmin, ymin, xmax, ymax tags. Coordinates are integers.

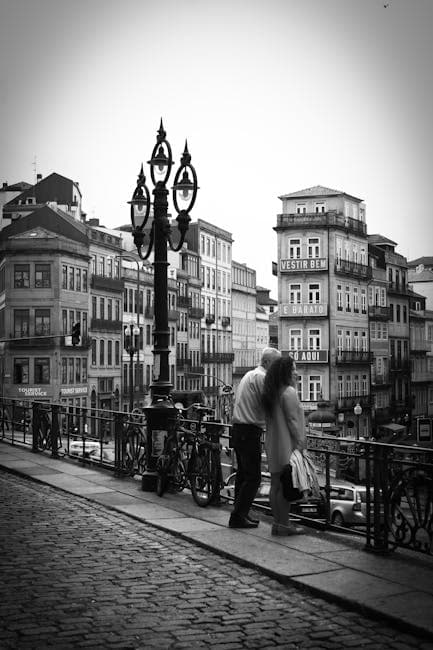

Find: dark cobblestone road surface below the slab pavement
<box><xmin>0</xmin><ymin>471</ymin><xmax>433</xmax><ymax>650</ymax></box>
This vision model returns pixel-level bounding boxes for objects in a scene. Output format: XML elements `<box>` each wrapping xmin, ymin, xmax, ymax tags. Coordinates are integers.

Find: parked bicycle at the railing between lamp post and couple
<box><xmin>156</xmin><ymin>404</ymin><xmax>222</xmax><ymax>507</ymax></box>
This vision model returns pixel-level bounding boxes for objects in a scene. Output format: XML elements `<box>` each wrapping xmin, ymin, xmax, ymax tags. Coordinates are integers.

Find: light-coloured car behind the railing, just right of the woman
<box><xmin>322</xmin><ymin>480</ymin><xmax>373</xmax><ymax>526</ymax></box>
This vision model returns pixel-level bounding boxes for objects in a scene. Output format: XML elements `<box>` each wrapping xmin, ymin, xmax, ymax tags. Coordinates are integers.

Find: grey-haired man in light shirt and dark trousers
<box><xmin>229</xmin><ymin>348</ymin><xmax>281</xmax><ymax>528</ymax></box>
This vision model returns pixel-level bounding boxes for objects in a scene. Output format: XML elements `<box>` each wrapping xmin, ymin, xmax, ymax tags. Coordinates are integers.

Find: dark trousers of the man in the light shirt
<box><xmin>232</xmin><ymin>424</ymin><xmax>262</xmax><ymax>518</ymax></box>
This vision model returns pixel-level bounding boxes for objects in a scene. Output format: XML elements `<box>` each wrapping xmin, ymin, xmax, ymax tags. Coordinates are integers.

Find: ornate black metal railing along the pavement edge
<box><xmin>0</xmin><ymin>398</ymin><xmax>433</xmax><ymax>555</ymax></box>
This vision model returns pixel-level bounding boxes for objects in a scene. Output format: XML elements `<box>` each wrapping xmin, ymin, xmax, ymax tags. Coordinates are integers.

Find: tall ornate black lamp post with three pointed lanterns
<box><xmin>129</xmin><ymin>120</ymin><xmax>198</xmax><ymax>490</ymax></box>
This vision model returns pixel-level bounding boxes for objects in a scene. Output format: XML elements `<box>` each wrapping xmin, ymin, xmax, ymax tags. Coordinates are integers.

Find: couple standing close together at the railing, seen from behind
<box><xmin>229</xmin><ymin>348</ymin><xmax>306</xmax><ymax>535</ymax></box>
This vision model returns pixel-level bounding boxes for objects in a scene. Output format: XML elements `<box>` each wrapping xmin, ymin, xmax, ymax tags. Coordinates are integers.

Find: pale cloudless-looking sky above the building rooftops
<box><xmin>0</xmin><ymin>0</ymin><xmax>433</xmax><ymax>298</ymax></box>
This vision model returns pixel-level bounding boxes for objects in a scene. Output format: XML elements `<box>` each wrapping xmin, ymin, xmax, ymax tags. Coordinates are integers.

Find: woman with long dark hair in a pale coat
<box><xmin>262</xmin><ymin>356</ymin><xmax>306</xmax><ymax>535</ymax></box>
